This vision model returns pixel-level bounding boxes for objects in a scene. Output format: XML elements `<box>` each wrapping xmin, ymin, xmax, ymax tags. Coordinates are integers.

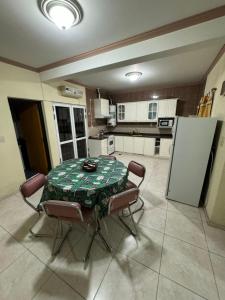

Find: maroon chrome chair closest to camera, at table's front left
<box><xmin>42</xmin><ymin>200</ymin><xmax>111</xmax><ymax>262</ymax></box>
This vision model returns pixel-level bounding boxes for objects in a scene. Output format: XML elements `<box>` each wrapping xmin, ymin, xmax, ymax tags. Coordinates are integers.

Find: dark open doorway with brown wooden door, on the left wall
<box><xmin>9</xmin><ymin>98</ymin><xmax>51</xmax><ymax>178</ymax></box>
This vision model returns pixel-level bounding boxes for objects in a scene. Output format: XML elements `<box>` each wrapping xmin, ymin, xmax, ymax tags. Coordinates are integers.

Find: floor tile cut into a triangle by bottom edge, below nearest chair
<box><xmin>33</xmin><ymin>275</ymin><xmax>83</xmax><ymax>300</ymax></box>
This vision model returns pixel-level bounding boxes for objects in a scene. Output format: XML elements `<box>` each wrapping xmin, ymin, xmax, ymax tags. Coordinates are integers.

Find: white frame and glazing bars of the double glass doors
<box><xmin>52</xmin><ymin>102</ymin><xmax>89</xmax><ymax>163</ymax></box>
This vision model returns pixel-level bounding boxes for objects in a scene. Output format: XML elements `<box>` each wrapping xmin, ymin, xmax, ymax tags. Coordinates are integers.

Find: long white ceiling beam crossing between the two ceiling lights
<box><xmin>40</xmin><ymin>17</ymin><xmax>225</xmax><ymax>81</ymax></box>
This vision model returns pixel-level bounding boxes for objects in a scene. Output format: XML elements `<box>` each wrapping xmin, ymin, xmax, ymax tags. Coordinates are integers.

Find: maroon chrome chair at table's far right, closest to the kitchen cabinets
<box><xmin>124</xmin><ymin>160</ymin><xmax>146</xmax><ymax>216</ymax></box>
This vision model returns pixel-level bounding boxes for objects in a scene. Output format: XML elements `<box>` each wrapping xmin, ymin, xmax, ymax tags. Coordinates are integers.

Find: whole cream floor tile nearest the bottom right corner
<box><xmin>160</xmin><ymin>236</ymin><xmax>218</xmax><ymax>300</ymax></box>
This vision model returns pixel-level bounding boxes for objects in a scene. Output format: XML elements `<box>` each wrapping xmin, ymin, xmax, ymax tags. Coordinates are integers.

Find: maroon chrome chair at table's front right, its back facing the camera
<box><xmin>108</xmin><ymin>188</ymin><xmax>139</xmax><ymax>236</ymax></box>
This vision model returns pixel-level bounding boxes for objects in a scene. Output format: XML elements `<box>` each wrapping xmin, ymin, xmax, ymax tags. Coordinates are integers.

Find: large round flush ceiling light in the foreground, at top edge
<box><xmin>39</xmin><ymin>0</ymin><xmax>82</xmax><ymax>30</ymax></box>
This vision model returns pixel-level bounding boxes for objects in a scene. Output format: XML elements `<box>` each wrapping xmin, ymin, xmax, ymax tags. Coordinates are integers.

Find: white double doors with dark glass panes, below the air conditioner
<box><xmin>54</xmin><ymin>104</ymin><xmax>87</xmax><ymax>162</ymax></box>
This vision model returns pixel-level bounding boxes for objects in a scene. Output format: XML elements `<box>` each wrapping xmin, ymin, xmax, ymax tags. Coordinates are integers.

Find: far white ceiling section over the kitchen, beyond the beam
<box><xmin>71</xmin><ymin>38</ymin><xmax>225</xmax><ymax>90</ymax></box>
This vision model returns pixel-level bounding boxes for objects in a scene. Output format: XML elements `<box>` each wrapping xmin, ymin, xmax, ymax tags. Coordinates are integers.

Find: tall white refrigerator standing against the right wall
<box><xmin>166</xmin><ymin>117</ymin><xmax>217</xmax><ymax>207</ymax></box>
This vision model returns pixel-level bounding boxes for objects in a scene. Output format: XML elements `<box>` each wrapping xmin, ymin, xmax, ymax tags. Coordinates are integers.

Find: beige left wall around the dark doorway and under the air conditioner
<box><xmin>0</xmin><ymin>62</ymin><xmax>86</xmax><ymax>198</ymax></box>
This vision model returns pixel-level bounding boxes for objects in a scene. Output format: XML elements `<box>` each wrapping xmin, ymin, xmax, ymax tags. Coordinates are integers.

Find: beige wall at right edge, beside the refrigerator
<box><xmin>205</xmin><ymin>53</ymin><xmax>225</xmax><ymax>225</ymax></box>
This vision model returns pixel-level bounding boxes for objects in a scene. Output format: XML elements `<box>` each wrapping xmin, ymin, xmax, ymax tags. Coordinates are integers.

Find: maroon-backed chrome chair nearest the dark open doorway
<box><xmin>20</xmin><ymin>173</ymin><xmax>48</xmax><ymax>237</ymax></box>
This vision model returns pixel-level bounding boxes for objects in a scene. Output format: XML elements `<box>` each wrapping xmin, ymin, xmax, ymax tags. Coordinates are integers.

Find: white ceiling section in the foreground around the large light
<box><xmin>0</xmin><ymin>0</ymin><xmax>224</xmax><ymax>67</ymax></box>
